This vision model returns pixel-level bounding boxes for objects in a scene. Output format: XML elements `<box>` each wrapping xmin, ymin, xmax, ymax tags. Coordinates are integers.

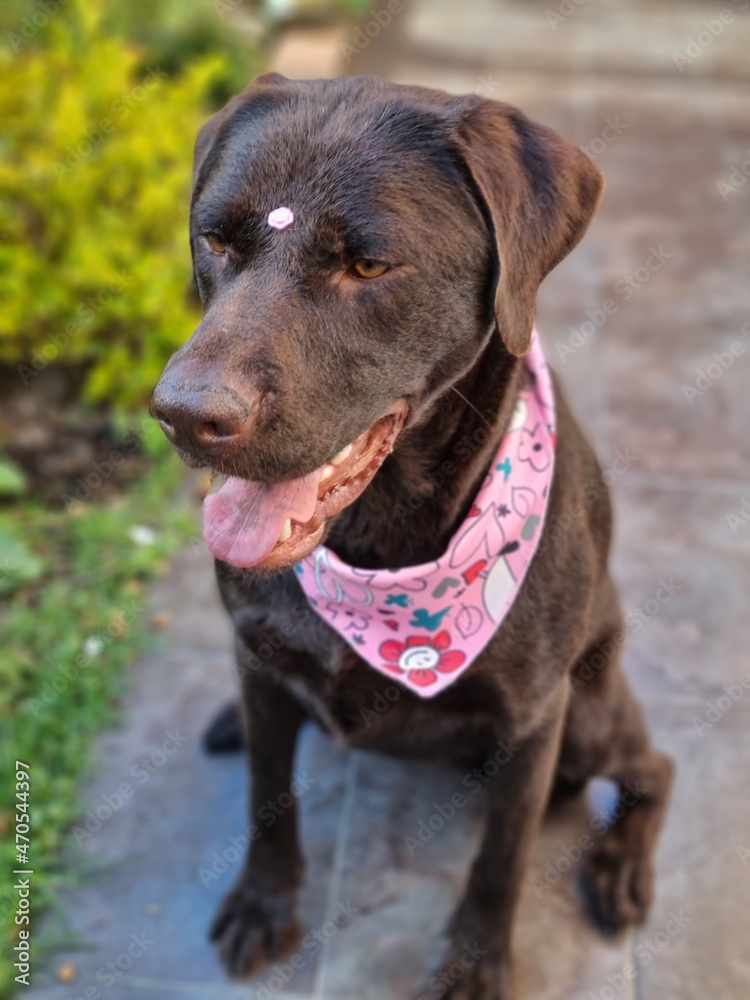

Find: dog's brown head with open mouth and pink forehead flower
<box><xmin>152</xmin><ymin>75</ymin><xmax>602</xmax><ymax>569</ymax></box>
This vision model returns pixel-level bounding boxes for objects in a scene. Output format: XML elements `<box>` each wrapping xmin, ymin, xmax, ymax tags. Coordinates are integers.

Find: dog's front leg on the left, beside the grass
<box><xmin>211</xmin><ymin>648</ymin><xmax>304</xmax><ymax>976</ymax></box>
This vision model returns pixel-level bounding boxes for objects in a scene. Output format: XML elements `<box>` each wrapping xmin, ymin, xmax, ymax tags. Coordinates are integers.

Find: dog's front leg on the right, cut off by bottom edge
<box><xmin>427</xmin><ymin>685</ymin><xmax>566</xmax><ymax>1000</ymax></box>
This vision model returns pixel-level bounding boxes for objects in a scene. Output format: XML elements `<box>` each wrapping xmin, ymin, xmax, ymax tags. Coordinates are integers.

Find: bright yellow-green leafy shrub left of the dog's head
<box><xmin>0</xmin><ymin>0</ymin><xmax>239</xmax><ymax>406</ymax></box>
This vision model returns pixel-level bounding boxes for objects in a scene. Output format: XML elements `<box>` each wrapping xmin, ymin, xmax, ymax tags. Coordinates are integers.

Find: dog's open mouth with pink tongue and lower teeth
<box><xmin>203</xmin><ymin>401</ymin><xmax>408</xmax><ymax>569</ymax></box>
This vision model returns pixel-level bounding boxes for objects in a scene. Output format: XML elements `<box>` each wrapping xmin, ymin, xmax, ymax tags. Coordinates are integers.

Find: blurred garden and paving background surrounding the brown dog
<box><xmin>0</xmin><ymin>0</ymin><xmax>750</xmax><ymax>1000</ymax></box>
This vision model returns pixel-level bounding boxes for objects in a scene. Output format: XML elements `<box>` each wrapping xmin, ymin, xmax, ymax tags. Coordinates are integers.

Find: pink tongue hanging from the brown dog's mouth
<box><xmin>203</xmin><ymin>469</ymin><xmax>321</xmax><ymax>567</ymax></box>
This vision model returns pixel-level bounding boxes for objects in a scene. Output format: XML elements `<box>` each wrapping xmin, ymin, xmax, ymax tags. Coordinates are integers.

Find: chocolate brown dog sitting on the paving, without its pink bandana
<box><xmin>152</xmin><ymin>75</ymin><xmax>672</xmax><ymax>1000</ymax></box>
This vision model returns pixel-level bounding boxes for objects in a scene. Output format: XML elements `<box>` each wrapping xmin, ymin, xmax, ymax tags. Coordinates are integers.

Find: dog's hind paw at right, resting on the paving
<box><xmin>581</xmin><ymin>835</ymin><xmax>653</xmax><ymax>935</ymax></box>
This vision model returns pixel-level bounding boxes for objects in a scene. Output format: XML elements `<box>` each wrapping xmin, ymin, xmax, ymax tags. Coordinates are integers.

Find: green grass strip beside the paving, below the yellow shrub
<box><xmin>0</xmin><ymin>429</ymin><xmax>196</xmax><ymax>996</ymax></box>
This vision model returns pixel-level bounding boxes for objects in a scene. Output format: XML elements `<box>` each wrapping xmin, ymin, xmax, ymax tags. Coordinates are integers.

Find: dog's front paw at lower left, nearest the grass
<box><xmin>209</xmin><ymin>881</ymin><xmax>300</xmax><ymax>976</ymax></box>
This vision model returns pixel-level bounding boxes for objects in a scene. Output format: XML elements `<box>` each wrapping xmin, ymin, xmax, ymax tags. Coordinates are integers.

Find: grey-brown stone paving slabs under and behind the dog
<box><xmin>24</xmin><ymin>0</ymin><xmax>750</xmax><ymax>1000</ymax></box>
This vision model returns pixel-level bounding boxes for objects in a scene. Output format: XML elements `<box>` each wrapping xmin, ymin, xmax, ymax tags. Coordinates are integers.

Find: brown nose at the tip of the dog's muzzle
<box><xmin>151</xmin><ymin>382</ymin><xmax>252</xmax><ymax>458</ymax></box>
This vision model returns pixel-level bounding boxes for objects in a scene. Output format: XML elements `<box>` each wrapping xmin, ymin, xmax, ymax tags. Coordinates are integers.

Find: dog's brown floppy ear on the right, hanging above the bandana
<box><xmin>452</xmin><ymin>98</ymin><xmax>604</xmax><ymax>357</ymax></box>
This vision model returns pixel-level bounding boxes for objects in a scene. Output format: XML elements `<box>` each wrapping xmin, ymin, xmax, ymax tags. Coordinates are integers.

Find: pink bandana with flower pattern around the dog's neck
<box><xmin>296</xmin><ymin>330</ymin><xmax>555</xmax><ymax>698</ymax></box>
